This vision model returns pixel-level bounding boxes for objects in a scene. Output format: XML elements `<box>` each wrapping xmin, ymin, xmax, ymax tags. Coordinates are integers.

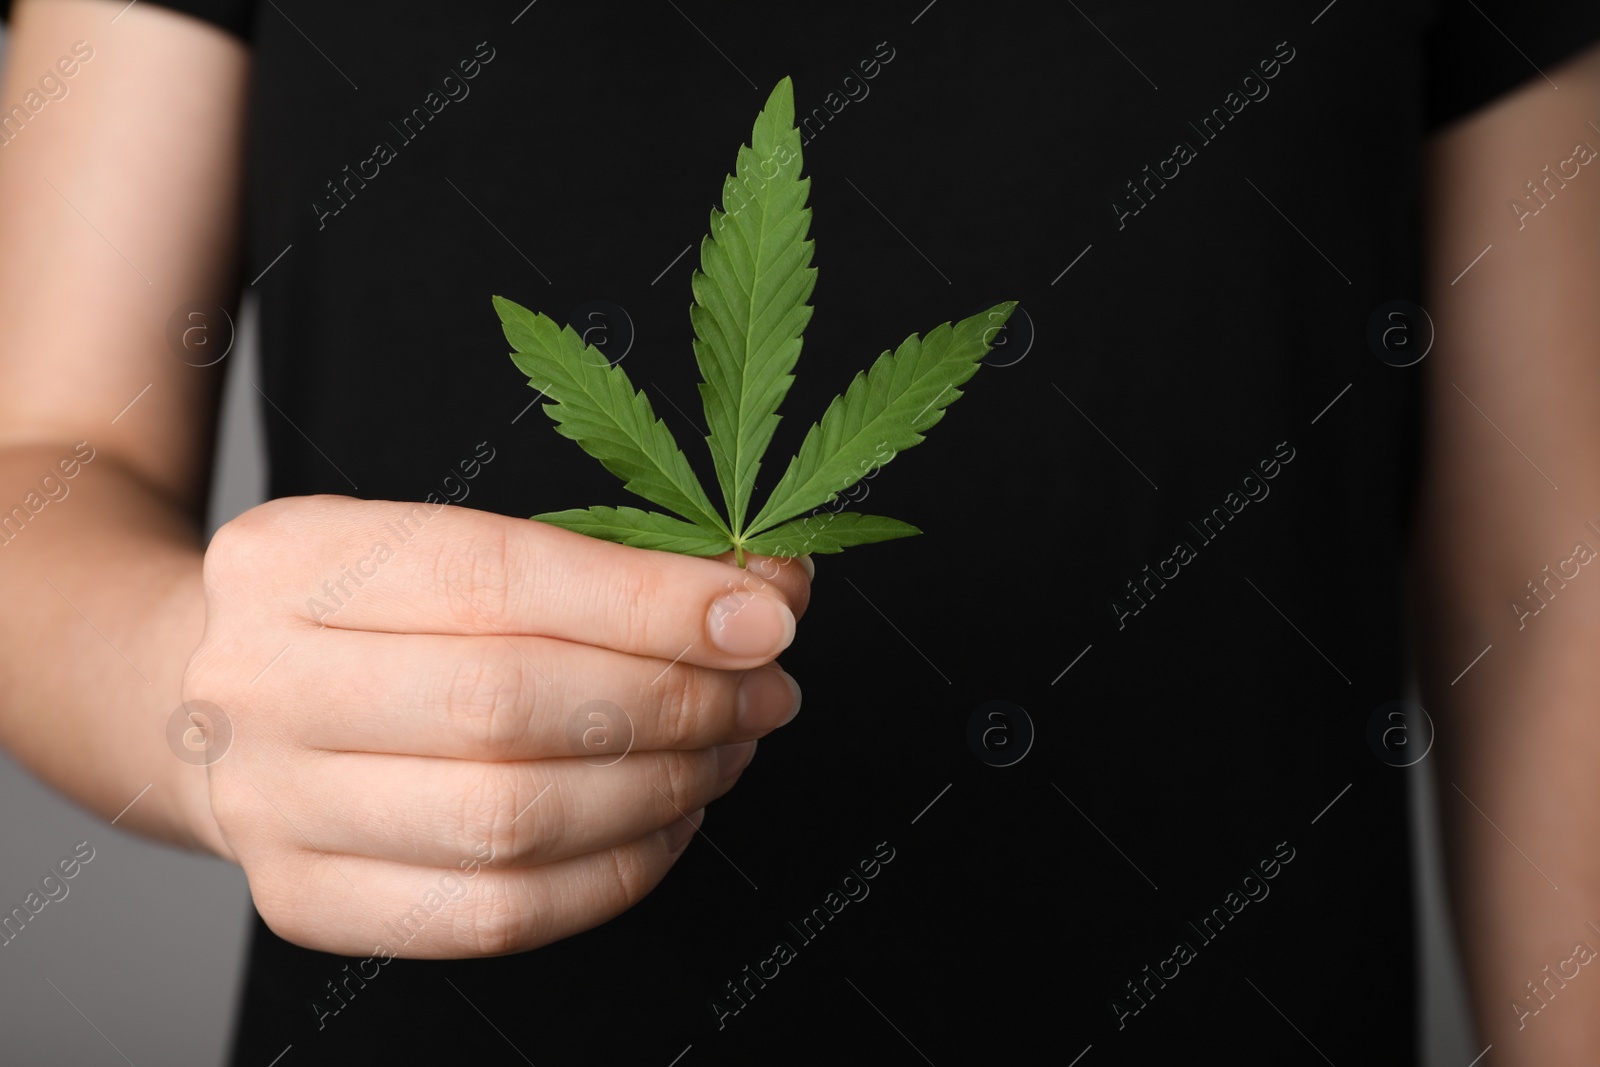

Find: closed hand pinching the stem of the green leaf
<box><xmin>184</xmin><ymin>496</ymin><xmax>810</xmax><ymax>958</ymax></box>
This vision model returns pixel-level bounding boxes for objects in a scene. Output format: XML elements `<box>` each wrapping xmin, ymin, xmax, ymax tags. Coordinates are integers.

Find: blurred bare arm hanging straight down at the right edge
<box><xmin>1414</xmin><ymin>35</ymin><xmax>1600</xmax><ymax>1067</ymax></box>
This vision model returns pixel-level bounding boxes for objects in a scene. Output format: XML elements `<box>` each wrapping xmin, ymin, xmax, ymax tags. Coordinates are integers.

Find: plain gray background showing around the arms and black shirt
<box><xmin>0</xmin><ymin>27</ymin><xmax>1482</xmax><ymax>1067</ymax></box>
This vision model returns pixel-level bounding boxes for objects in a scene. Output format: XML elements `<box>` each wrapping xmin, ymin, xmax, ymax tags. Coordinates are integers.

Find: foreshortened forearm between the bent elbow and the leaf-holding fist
<box><xmin>0</xmin><ymin>442</ymin><xmax>226</xmax><ymax>854</ymax></box>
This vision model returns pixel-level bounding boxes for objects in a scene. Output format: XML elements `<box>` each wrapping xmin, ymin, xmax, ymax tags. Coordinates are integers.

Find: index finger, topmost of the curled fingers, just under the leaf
<box><xmin>230</xmin><ymin>498</ymin><xmax>810</xmax><ymax>670</ymax></box>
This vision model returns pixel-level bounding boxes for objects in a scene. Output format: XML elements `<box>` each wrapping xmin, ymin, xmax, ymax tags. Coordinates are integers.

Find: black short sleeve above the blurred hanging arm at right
<box><xmin>1427</xmin><ymin>0</ymin><xmax>1600</xmax><ymax>133</ymax></box>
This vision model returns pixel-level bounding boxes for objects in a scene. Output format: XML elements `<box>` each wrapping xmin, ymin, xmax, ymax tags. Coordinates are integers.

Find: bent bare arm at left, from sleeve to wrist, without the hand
<box><xmin>0</xmin><ymin>0</ymin><xmax>248</xmax><ymax>849</ymax></box>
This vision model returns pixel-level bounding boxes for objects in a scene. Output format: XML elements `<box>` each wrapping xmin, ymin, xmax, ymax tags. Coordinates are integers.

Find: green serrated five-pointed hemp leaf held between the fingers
<box><xmin>494</xmin><ymin>78</ymin><xmax>1016</xmax><ymax>566</ymax></box>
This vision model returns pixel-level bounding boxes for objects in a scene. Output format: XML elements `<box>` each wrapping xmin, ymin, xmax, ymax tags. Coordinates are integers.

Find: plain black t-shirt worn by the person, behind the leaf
<box><xmin>9</xmin><ymin>0</ymin><xmax>1600</xmax><ymax>1067</ymax></box>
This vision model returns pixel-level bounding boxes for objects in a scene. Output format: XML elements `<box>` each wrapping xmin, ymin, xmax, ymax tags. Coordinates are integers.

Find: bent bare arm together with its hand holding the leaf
<box><xmin>0</xmin><ymin>0</ymin><xmax>810</xmax><ymax>958</ymax></box>
